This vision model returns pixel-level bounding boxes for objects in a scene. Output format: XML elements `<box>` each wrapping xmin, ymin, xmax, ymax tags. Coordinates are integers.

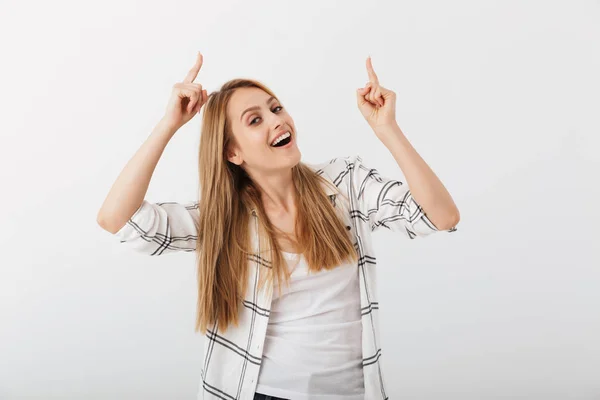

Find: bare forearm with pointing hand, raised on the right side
<box><xmin>356</xmin><ymin>57</ymin><xmax>460</xmax><ymax>230</ymax></box>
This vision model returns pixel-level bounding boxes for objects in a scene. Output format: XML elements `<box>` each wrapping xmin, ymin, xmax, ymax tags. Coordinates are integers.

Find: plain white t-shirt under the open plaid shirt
<box><xmin>256</xmin><ymin>252</ymin><xmax>364</xmax><ymax>400</ymax></box>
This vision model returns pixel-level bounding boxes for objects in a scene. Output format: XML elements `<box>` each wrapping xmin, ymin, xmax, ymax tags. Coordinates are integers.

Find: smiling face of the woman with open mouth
<box><xmin>227</xmin><ymin>88</ymin><xmax>301</xmax><ymax>172</ymax></box>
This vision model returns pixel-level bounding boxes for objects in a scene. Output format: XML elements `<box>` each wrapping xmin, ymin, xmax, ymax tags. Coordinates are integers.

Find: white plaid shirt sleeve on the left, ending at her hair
<box><xmin>115</xmin><ymin>200</ymin><xmax>198</xmax><ymax>256</ymax></box>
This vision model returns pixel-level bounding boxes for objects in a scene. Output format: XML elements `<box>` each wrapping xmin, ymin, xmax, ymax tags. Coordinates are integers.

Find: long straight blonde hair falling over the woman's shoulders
<box><xmin>196</xmin><ymin>79</ymin><xmax>358</xmax><ymax>333</ymax></box>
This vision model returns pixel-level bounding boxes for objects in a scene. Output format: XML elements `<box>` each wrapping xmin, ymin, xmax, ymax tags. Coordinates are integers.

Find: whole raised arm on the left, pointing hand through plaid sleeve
<box><xmin>97</xmin><ymin>53</ymin><xmax>208</xmax><ymax>254</ymax></box>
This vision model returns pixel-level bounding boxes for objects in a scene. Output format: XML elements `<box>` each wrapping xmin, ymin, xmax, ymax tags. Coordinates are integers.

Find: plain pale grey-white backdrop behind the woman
<box><xmin>0</xmin><ymin>0</ymin><xmax>600</xmax><ymax>400</ymax></box>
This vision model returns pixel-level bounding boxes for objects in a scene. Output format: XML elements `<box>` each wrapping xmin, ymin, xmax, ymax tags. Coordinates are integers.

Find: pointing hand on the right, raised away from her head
<box><xmin>356</xmin><ymin>57</ymin><xmax>397</xmax><ymax>132</ymax></box>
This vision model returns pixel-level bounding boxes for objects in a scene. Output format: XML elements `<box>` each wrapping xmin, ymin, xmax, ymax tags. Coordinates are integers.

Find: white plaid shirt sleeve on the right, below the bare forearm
<box><xmin>349</xmin><ymin>155</ymin><xmax>456</xmax><ymax>239</ymax></box>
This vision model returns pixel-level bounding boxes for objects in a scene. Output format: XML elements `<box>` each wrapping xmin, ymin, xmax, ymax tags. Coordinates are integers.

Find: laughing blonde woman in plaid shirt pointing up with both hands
<box><xmin>98</xmin><ymin>53</ymin><xmax>459</xmax><ymax>400</ymax></box>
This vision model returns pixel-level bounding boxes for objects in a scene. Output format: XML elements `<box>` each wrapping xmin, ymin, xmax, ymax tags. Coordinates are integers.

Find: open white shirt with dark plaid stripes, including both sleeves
<box><xmin>115</xmin><ymin>155</ymin><xmax>456</xmax><ymax>400</ymax></box>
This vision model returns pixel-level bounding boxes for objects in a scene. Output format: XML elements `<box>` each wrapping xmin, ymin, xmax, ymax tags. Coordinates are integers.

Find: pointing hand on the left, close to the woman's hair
<box><xmin>163</xmin><ymin>52</ymin><xmax>208</xmax><ymax>129</ymax></box>
